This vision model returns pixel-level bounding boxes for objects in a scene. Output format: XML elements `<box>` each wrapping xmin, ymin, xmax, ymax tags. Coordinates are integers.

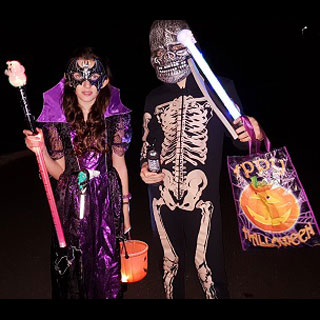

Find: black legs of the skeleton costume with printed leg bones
<box><xmin>150</xmin><ymin>188</ymin><xmax>229</xmax><ymax>299</ymax></box>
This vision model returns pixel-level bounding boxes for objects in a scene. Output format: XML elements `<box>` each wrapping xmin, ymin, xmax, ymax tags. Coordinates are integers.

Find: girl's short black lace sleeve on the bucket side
<box><xmin>112</xmin><ymin>114</ymin><xmax>132</xmax><ymax>157</ymax></box>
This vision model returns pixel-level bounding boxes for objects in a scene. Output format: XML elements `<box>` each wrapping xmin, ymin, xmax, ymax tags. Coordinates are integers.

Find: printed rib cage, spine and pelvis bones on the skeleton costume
<box><xmin>154</xmin><ymin>95</ymin><xmax>213</xmax><ymax>211</ymax></box>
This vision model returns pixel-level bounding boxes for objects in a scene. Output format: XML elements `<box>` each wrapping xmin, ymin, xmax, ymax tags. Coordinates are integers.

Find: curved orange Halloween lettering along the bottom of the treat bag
<box><xmin>242</xmin><ymin>223</ymin><xmax>315</xmax><ymax>248</ymax></box>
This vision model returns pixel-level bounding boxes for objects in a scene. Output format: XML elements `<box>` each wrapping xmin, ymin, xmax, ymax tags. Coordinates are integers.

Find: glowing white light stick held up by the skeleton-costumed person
<box><xmin>178</xmin><ymin>29</ymin><xmax>241</xmax><ymax>120</ymax></box>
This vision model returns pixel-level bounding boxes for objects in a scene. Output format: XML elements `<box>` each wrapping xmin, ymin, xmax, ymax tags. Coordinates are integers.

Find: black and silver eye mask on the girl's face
<box><xmin>66</xmin><ymin>59</ymin><xmax>108</xmax><ymax>91</ymax></box>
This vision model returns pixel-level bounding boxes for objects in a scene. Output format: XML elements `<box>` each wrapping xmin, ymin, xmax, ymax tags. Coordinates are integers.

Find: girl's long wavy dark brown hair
<box><xmin>63</xmin><ymin>47</ymin><xmax>111</xmax><ymax>156</ymax></box>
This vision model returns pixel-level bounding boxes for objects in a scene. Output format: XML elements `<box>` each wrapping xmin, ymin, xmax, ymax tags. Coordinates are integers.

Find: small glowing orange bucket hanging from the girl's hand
<box><xmin>120</xmin><ymin>240</ymin><xmax>149</xmax><ymax>283</ymax></box>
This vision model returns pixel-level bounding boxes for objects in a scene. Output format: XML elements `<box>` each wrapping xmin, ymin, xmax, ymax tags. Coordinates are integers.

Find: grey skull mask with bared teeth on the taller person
<box><xmin>149</xmin><ymin>20</ymin><xmax>191</xmax><ymax>83</ymax></box>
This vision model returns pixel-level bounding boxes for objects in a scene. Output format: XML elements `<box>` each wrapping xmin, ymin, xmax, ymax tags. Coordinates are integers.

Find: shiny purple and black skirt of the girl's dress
<box><xmin>55</xmin><ymin>166</ymin><xmax>121</xmax><ymax>299</ymax></box>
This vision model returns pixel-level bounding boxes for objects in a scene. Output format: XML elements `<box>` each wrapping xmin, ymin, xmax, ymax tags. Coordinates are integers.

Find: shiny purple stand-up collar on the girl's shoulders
<box><xmin>37</xmin><ymin>79</ymin><xmax>131</xmax><ymax>123</ymax></box>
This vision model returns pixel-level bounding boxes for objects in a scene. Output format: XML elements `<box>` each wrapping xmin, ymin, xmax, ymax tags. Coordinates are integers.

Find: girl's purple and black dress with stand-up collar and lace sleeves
<box><xmin>38</xmin><ymin>80</ymin><xmax>132</xmax><ymax>299</ymax></box>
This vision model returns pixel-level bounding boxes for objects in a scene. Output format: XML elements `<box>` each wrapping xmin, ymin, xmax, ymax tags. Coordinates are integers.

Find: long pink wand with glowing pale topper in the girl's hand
<box><xmin>5</xmin><ymin>61</ymin><xmax>67</xmax><ymax>248</ymax></box>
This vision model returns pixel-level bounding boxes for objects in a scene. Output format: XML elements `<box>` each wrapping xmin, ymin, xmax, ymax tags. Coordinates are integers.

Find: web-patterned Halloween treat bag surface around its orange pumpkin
<box><xmin>228</xmin><ymin>147</ymin><xmax>320</xmax><ymax>250</ymax></box>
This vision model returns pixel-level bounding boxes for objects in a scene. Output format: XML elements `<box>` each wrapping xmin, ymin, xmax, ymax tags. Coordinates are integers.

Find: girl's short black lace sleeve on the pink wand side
<box><xmin>42</xmin><ymin>123</ymin><xmax>64</xmax><ymax>160</ymax></box>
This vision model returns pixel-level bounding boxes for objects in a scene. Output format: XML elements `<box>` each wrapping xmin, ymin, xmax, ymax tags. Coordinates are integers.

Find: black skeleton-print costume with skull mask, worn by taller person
<box><xmin>141</xmin><ymin>20</ymin><xmax>249</xmax><ymax>299</ymax></box>
